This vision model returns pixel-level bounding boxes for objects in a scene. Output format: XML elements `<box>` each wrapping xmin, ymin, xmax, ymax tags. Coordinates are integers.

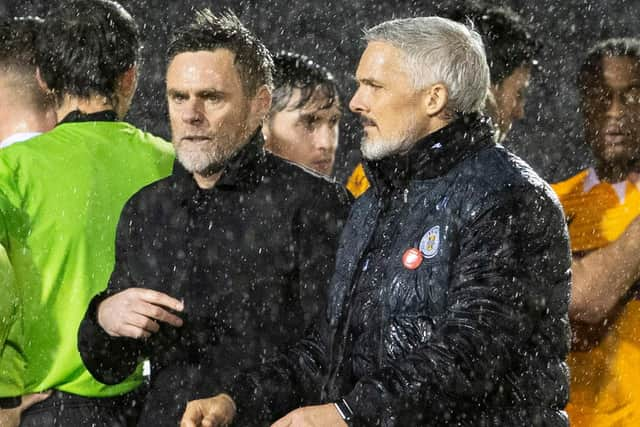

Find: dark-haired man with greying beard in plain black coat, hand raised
<box><xmin>79</xmin><ymin>10</ymin><xmax>348</xmax><ymax>426</ymax></box>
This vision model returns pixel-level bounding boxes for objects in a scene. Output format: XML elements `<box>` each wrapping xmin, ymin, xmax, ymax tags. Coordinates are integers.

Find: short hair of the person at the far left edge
<box><xmin>0</xmin><ymin>16</ymin><xmax>43</xmax><ymax>72</ymax></box>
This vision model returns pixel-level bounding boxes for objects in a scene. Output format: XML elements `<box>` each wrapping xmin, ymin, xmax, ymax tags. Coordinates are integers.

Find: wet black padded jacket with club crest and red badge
<box><xmin>230</xmin><ymin>116</ymin><xmax>571</xmax><ymax>427</ymax></box>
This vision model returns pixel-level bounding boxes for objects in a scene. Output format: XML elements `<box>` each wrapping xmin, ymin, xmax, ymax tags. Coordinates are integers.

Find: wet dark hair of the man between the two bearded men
<box><xmin>271</xmin><ymin>51</ymin><xmax>340</xmax><ymax>114</ymax></box>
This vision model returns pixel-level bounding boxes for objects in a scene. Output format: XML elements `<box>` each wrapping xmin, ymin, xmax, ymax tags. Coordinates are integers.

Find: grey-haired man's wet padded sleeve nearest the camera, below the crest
<box><xmin>345</xmin><ymin>186</ymin><xmax>571</xmax><ymax>425</ymax></box>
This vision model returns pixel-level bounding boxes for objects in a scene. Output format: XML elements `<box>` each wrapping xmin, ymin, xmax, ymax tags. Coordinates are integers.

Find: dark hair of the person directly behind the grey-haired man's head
<box><xmin>447</xmin><ymin>1</ymin><xmax>542</xmax><ymax>84</ymax></box>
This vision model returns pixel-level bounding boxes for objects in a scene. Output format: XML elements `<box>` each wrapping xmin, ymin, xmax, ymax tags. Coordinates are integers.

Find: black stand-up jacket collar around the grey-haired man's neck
<box><xmin>365</xmin><ymin>113</ymin><xmax>495</xmax><ymax>192</ymax></box>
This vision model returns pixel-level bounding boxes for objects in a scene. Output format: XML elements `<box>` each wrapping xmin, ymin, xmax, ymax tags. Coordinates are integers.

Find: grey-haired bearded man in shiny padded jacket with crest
<box><xmin>183</xmin><ymin>17</ymin><xmax>571</xmax><ymax>427</ymax></box>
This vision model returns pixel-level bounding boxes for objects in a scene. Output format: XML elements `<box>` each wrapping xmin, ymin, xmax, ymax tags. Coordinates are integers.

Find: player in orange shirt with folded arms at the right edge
<box><xmin>553</xmin><ymin>38</ymin><xmax>640</xmax><ymax>427</ymax></box>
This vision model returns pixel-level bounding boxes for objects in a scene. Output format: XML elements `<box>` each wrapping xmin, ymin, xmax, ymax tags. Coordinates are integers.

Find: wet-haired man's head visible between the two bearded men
<box><xmin>262</xmin><ymin>52</ymin><xmax>342</xmax><ymax>176</ymax></box>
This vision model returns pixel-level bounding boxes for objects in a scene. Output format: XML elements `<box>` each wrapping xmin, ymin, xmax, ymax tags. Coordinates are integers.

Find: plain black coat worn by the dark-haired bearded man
<box><xmin>79</xmin><ymin>135</ymin><xmax>350</xmax><ymax>426</ymax></box>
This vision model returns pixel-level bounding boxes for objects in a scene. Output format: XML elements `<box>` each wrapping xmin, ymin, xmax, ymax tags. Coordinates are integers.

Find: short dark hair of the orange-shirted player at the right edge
<box><xmin>577</xmin><ymin>37</ymin><xmax>640</xmax><ymax>94</ymax></box>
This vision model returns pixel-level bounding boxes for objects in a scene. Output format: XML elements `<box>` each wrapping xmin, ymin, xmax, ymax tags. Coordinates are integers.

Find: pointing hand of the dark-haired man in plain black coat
<box><xmin>97</xmin><ymin>288</ymin><xmax>184</xmax><ymax>338</ymax></box>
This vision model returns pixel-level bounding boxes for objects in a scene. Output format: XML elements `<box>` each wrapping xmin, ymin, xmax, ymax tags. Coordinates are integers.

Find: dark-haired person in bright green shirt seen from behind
<box><xmin>0</xmin><ymin>0</ymin><xmax>174</xmax><ymax>427</ymax></box>
